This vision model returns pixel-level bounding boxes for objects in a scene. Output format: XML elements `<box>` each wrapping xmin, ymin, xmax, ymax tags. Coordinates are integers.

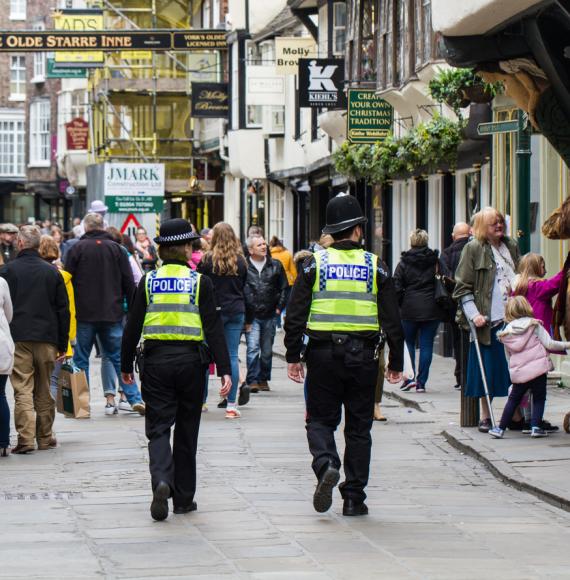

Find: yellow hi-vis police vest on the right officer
<box><xmin>307</xmin><ymin>248</ymin><xmax>380</xmax><ymax>332</ymax></box>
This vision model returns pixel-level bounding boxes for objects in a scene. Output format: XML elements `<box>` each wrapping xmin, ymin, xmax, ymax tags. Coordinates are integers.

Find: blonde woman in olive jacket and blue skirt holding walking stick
<box><xmin>453</xmin><ymin>207</ymin><xmax>519</xmax><ymax>433</ymax></box>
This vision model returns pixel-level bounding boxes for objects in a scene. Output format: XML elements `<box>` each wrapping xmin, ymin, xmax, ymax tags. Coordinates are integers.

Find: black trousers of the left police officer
<box><xmin>142</xmin><ymin>344</ymin><xmax>206</xmax><ymax>506</ymax></box>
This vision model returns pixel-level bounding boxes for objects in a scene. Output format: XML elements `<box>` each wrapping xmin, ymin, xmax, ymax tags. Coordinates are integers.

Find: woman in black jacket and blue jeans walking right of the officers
<box><xmin>394</xmin><ymin>229</ymin><xmax>447</xmax><ymax>393</ymax></box>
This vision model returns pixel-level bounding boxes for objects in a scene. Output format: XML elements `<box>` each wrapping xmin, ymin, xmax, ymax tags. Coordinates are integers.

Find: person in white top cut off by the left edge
<box><xmin>0</xmin><ymin>278</ymin><xmax>14</xmax><ymax>457</ymax></box>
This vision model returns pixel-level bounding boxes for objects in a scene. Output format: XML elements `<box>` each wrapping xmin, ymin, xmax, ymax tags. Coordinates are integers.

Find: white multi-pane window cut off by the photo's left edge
<box><xmin>0</xmin><ymin>109</ymin><xmax>26</xmax><ymax>178</ymax></box>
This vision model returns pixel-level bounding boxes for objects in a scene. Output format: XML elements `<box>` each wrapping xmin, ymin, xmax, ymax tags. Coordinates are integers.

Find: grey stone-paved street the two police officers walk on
<box><xmin>0</xmin><ymin>346</ymin><xmax>570</xmax><ymax>580</ymax></box>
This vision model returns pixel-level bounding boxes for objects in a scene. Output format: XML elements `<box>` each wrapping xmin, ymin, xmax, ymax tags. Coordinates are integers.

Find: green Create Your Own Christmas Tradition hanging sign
<box><xmin>346</xmin><ymin>89</ymin><xmax>394</xmax><ymax>143</ymax></box>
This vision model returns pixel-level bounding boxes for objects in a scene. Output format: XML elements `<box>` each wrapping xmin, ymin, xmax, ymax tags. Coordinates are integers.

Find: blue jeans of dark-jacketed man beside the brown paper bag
<box><xmin>73</xmin><ymin>320</ymin><xmax>141</xmax><ymax>405</ymax></box>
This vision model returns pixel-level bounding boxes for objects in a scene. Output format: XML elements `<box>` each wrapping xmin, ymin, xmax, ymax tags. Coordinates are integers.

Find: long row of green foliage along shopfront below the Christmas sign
<box><xmin>333</xmin><ymin>115</ymin><xmax>464</xmax><ymax>184</ymax></box>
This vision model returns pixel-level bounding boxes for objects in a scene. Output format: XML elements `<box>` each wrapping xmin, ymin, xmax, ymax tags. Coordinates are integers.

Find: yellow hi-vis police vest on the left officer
<box><xmin>143</xmin><ymin>264</ymin><xmax>204</xmax><ymax>341</ymax></box>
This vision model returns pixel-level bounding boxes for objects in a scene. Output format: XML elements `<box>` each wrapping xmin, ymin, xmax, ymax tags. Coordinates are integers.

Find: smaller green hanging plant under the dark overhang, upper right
<box><xmin>429</xmin><ymin>68</ymin><xmax>503</xmax><ymax>117</ymax></box>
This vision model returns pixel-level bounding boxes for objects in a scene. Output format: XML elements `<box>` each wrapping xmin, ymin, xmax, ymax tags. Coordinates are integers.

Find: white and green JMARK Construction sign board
<box><xmin>103</xmin><ymin>163</ymin><xmax>165</xmax><ymax>213</ymax></box>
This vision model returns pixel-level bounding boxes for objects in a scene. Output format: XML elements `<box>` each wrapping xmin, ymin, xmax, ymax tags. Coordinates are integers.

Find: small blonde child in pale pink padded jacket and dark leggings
<box><xmin>489</xmin><ymin>296</ymin><xmax>570</xmax><ymax>439</ymax></box>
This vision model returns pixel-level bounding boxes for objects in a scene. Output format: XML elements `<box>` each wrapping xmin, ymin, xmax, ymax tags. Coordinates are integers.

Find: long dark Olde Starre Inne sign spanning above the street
<box><xmin>0</xmin><ymin>30</ymin><xmax>227</xmax><ymax>53</ymax></box>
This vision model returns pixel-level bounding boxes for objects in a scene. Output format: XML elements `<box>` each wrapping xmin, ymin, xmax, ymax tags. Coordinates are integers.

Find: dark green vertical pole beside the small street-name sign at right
<box><xmin>516</xmin><ymin>109</ymin><xmax>531</xmax><ymax>254</ymax></box>
